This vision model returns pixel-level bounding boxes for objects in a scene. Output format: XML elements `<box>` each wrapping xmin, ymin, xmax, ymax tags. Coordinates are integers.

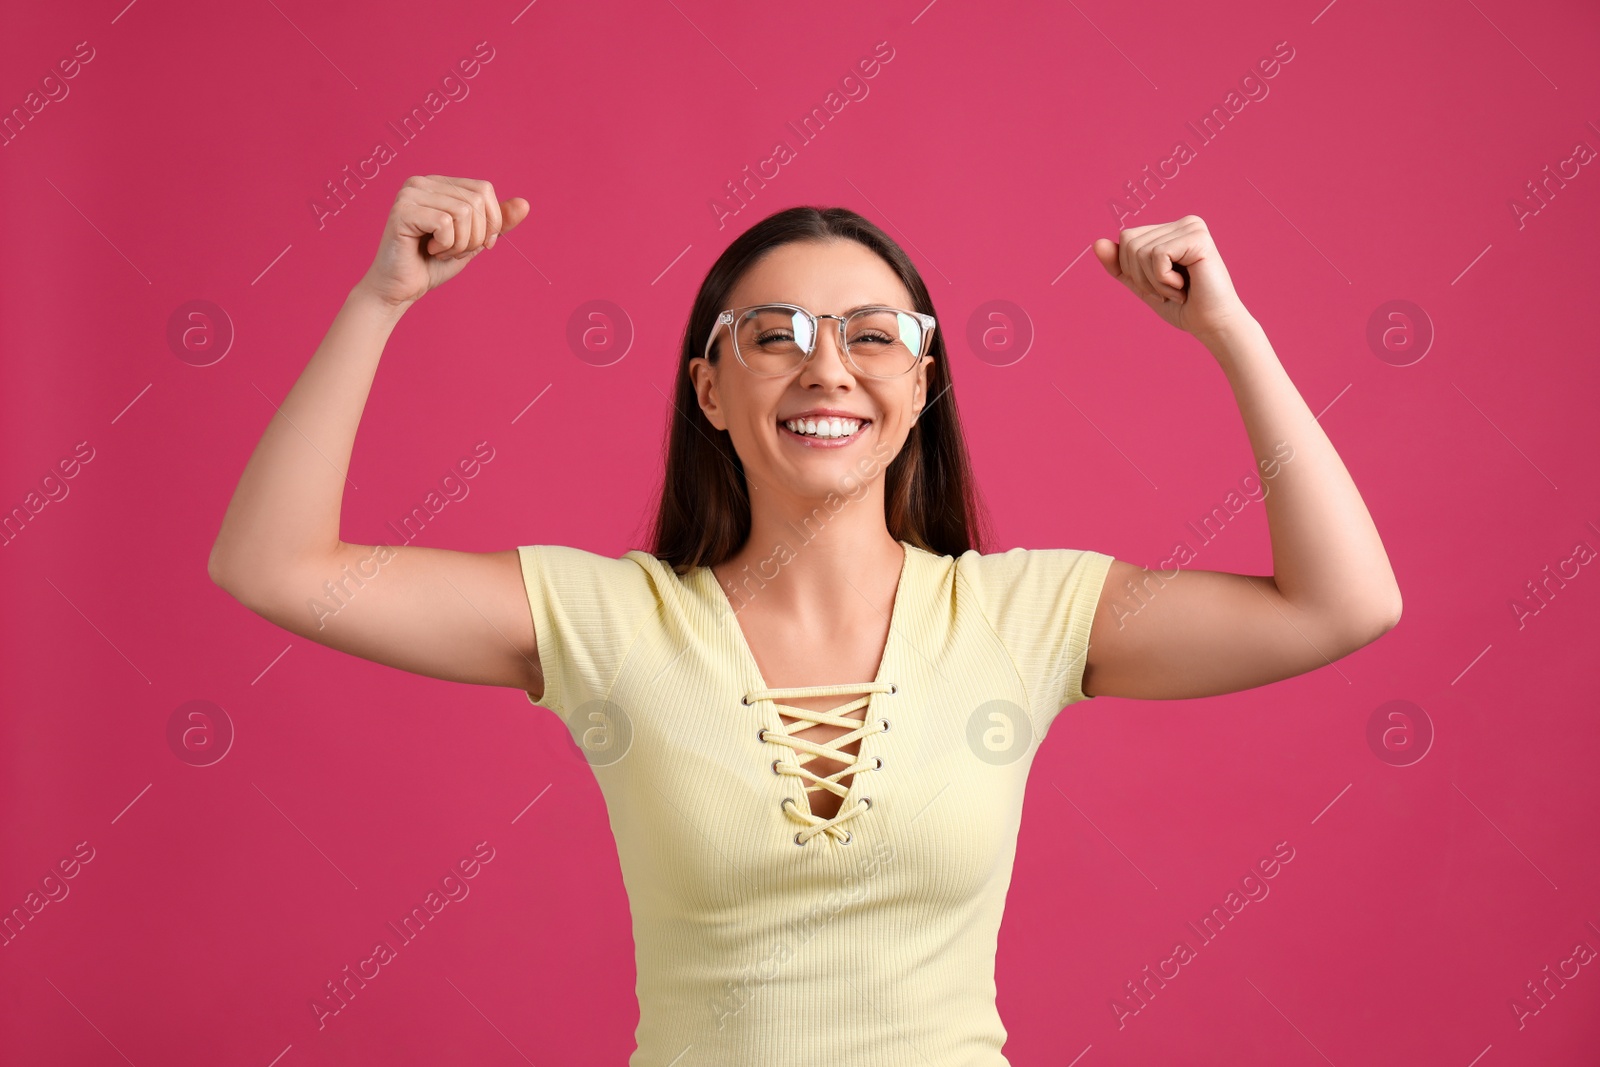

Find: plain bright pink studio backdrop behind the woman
<box><xmin>0</xmin><ymin>0</ymin><xmax>1600</xmax><ymax>1067</ymax></box>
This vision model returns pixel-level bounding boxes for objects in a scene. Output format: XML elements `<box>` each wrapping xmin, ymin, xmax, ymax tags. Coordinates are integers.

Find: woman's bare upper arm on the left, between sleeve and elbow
<box><xmin>219</xmin><ymin>544</ymin><xmax>544</xmax><ymax>696</ymax></box>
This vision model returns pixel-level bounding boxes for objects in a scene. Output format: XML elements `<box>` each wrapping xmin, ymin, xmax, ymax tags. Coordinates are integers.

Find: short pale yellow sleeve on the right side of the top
<box><xmin>960</xmin><ymin>549</ymin><xmax>1115</xmax><ymax>733</ymax></box>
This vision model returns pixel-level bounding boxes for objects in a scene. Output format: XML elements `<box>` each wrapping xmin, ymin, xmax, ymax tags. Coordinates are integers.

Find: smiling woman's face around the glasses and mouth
<box><xmin>690</xmin><ymin>238</ymin><xmax>933</xmax><ymax>499</ymax></box>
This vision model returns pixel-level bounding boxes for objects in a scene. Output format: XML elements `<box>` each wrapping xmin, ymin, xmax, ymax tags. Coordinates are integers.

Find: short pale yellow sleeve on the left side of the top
<box><xmin>517</xmin><ymin>544</ymin><xmax>666</xmax><ymax>718</ymax></box>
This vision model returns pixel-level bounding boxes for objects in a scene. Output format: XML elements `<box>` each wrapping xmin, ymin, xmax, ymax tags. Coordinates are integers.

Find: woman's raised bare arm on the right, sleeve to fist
<box><xmin>1083</xmin><ymin>214</ymin><xmax>1400</xmax><ymax>699</ymax></box>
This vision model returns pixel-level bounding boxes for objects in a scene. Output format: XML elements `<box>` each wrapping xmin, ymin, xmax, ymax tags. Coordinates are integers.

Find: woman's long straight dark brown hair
<box><xmin>651</xmin><ymin>206</ymin><xmax>987</xmax><ymax>574</ymax></box>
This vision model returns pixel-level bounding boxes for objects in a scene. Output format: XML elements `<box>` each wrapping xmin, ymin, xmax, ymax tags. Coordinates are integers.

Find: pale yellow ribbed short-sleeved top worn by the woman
<box><xmin>518</xmin><ymin>541</ymin><xmax>1112</xmax><ymax>1067</ymax></box>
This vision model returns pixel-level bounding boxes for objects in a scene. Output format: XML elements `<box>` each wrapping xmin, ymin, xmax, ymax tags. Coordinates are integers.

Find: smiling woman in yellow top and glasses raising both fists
<box><xmin>210</xmin><ymin>176</ymin><xmax>1400</xmax><ymax>1067</ymax></box>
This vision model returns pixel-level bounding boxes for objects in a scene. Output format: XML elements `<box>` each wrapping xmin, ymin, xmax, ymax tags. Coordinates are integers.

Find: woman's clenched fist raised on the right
<box><xmin>1094</xmin><ymin>214</ymin><xmax>1251</xmax><ymax>341</ymax></box>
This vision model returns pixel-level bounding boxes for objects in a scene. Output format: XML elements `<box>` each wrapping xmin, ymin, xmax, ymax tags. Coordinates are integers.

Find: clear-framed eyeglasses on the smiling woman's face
<box><xmin>706</xmin><ymin>304</ymin><xmax>934</xmax><ymax>378</ymax></box>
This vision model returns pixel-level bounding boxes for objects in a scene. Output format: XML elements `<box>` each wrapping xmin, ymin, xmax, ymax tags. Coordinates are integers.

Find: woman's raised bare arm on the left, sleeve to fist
<box><xmin>208</xmin><ymin>174</ymin><xmax>544</xmax><ymax>697</ymax></box>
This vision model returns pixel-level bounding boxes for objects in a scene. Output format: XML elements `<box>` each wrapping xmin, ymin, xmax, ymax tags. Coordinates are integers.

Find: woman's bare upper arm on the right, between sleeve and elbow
<box><xmin>1083</xmin><ymin>560</ymin><xmax>1390</xmax><ymax>699</ymax></box>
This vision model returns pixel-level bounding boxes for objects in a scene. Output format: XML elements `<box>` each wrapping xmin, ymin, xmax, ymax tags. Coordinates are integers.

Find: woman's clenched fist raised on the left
<box><xmin>362</xmin><ymin>174</ymin><xmax>530</xmax><ymax>307</ymax></box>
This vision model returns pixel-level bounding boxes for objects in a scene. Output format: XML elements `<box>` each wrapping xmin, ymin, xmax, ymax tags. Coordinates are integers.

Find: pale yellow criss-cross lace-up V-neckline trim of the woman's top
<box><xmin>701</xmin><ymin>541</ymin><xmax>920</xmax><ymax>845</ymax></box>
